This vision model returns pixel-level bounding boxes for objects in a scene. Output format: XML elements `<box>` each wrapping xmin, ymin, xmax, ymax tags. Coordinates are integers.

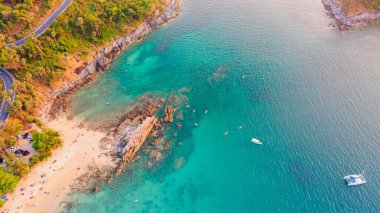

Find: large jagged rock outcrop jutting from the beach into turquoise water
<box><xmin>98</xmin><ymin>93</ymin><xmax>189</xmax><ymax>183</ymax></box>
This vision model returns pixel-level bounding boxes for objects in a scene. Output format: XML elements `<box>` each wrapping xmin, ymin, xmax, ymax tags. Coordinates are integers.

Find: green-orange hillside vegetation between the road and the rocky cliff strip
<box><xmin>0</xmin><ymin>0</ymin><xmax>162</xmax><ymax>130</ymax></box>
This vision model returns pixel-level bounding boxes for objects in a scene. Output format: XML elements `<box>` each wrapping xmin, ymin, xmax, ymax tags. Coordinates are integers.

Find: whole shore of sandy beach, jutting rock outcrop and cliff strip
<box><xmin>4</xmin><ymin>0</ymin><xmax>179</xmax><ymax>212</ymax></box>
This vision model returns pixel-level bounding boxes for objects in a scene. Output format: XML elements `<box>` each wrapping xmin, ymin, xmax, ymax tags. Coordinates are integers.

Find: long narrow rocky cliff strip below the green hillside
<box><xmin>52</xmin><ymin>0</ymin><xmax>179</xmax><ymax>97</ymax></box>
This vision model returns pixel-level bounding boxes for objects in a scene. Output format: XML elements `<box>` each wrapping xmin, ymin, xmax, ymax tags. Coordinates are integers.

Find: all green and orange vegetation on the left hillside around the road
<box><xmin>0</xmin><ymin>0</ymin><xmax>163</xmax><ymax>201</ymax></box>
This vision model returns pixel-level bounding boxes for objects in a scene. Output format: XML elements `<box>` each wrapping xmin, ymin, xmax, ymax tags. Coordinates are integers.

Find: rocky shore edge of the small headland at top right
<box><xmin>322</xmin><ymin>0</ymin><xmax>380</xmax><ymax>31</ymax></box>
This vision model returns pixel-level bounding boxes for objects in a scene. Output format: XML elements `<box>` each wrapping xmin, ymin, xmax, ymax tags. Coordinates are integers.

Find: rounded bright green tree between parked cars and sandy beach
<box><xmin>32</xmin><ymin>129</ymin><xmax>63</xmax><ymax>154</ymax></box>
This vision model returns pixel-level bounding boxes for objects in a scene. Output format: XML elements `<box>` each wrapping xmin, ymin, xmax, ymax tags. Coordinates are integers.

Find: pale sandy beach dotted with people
<box><xmin>2</xmin><ymin>117</ymin><xmax>114</xmax><ymax>213</ymax></box>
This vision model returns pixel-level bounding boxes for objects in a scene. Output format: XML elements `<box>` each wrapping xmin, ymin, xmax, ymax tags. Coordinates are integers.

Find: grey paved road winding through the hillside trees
<box><xmin>0</xmin><ymin>0</ymin><xmax>72</xmax><ymax>129</ymax></box>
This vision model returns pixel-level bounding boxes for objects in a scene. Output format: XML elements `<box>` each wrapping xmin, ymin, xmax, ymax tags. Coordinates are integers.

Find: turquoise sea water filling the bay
<box><xmin>69</xmin><ymin>0</ymin><xmax>380</xmax><ymax>213</ymax></box>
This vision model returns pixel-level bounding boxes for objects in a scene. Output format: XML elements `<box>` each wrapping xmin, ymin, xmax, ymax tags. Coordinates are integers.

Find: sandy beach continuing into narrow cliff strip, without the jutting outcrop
<box><xmin>2</xmin><ymin>0</ymin><xmax>180</xmax><ymax>212</ymax></box>
